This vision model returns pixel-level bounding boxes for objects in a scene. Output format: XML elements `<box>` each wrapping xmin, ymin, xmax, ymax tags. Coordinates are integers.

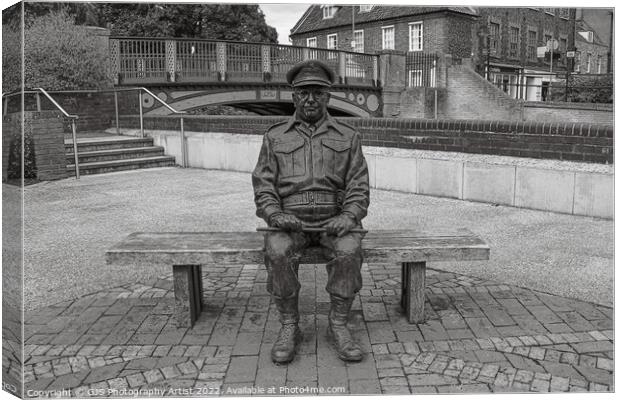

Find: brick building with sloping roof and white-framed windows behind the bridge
<box><xmin>290</xmin><ymin>5</ymin><xmax>477</xmax><ymax>57</ymax></box>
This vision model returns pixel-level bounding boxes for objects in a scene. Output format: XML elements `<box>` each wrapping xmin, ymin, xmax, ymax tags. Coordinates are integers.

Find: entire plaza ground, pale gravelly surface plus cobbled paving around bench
<box><xmin>5</xmin><ymin>168</ymin><xmax>614</xmax><ymax>398</ymax></box>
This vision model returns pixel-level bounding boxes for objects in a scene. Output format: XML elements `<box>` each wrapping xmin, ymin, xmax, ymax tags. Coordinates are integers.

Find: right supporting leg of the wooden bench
<box><xmin>400</xmin><ymin>262</ymin><xmax>426</xmax><ymax>324</ymax></box>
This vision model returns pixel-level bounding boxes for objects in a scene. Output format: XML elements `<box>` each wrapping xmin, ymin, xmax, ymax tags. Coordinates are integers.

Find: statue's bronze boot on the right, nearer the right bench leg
<box><xmin>327</xmin><ymin>295</ymin><xmax>363</xmax><ymax>361</ymax></box>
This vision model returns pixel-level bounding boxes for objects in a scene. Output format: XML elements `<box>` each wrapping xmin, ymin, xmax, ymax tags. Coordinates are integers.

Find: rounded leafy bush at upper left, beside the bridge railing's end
<box><xmin>24</xmin><ymin>11</ymin><xmax>108</xmax><ymax>90</ymax></box>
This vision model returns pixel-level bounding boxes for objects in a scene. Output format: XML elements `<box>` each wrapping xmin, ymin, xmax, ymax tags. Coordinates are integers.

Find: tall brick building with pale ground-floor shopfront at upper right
<box><xmin>475</xmin><ymin>7</ymin><xmax>575</xmax><ymax>101</ymax></box>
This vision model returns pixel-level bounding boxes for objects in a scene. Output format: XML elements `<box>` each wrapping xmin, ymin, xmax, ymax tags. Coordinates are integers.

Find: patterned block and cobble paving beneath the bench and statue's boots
<box><xmin>18</xmin><ymin>265</ymin><xmax>614</xmax><ymax>398</ymax></box>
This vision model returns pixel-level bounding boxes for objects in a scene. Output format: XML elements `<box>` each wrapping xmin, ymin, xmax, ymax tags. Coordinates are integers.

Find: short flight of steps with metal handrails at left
<box><xmin>65</xmin><ymin>132</ymin><xmax>175</xmax><ymax>176</ymax></box>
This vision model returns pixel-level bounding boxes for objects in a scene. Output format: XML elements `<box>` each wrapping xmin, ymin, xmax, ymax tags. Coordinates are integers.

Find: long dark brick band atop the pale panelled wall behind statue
<box><xmin>121</xmin><ymin>116</ymin><xmax>613</xmax><ymax>163</ymax></box>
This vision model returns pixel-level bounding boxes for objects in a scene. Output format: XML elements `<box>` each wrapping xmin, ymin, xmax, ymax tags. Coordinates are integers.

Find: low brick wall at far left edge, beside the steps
<box><xmin>2</xmin><ymin>111</ymin><xmax>67</xmax><ymax>181</ymax></box>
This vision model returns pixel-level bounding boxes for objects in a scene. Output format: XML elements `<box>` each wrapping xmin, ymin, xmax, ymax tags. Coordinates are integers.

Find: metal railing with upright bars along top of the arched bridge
<box><xmin>110</xmin><ymin>37</ymin><xmax>379</xmax><ymax>86</ymax></box>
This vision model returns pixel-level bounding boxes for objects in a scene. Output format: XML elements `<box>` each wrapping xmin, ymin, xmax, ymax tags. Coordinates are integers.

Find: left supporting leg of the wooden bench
<box><xmin>172</xmin><ymin>265</ymin><xmax>202</xmax><ymax>328</ymax></box>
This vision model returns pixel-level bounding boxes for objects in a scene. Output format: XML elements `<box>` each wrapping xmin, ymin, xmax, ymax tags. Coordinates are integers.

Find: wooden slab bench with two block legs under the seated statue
<box><xmin>106</xmin><ymin>229</ymin><xmax>489</xmax><ymax>327</ymax></box>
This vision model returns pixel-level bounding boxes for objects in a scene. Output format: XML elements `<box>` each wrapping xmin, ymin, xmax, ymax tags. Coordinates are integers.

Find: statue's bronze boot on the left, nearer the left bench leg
<box><xmin>271</xmin><ymin>296</ymin><xmax>301</xmax><ymax>364</ymax></box>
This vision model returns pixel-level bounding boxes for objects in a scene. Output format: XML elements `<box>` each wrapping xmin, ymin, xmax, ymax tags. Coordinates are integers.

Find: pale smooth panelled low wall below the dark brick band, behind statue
<box><xmin>114</xmin><ymin>130</ymin><xmax>614</xmax><ymax>218</ymax></box>
